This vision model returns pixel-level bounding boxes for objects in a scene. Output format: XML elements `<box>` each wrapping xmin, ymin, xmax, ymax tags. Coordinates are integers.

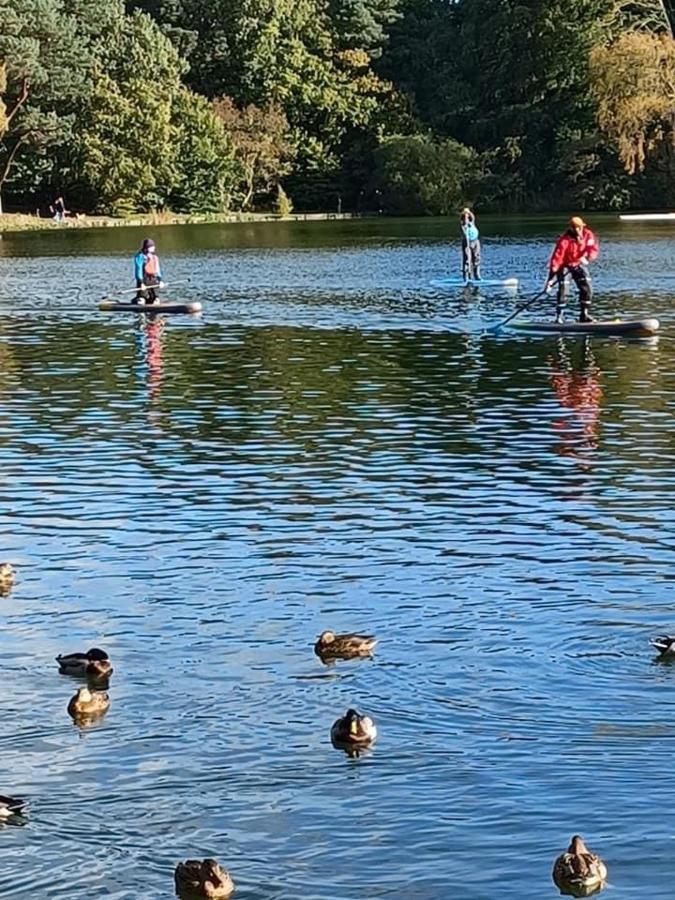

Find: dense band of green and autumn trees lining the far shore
<box><xmin>0</xmin><ymin>0</ymin><xmax>675</xmax><ymax>215</ymax></box>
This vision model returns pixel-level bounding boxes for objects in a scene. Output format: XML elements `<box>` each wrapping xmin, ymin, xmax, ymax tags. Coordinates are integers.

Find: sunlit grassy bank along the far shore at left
<box><xmin>0</xmin><ymin>212</ymin><xmax>365</xmax><ymax>234</ymax></box>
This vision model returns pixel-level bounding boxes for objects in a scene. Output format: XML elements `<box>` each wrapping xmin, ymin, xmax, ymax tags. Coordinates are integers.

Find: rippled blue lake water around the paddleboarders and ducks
<box><xmin>0</xmin><ymin>217</ymin><xmax>675</xmax><ymax>900</ymax></box>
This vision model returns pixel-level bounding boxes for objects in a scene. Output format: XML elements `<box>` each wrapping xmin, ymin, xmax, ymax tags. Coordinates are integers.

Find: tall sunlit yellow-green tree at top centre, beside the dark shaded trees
<box><xmin>131</xmin><ymin>0</ymin><xmax>406</xmax><ymax>206</ymax></box>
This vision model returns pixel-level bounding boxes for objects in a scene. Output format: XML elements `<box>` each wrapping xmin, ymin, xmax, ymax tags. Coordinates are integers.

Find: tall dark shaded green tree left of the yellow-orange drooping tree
<box><xmin>382</xmin><ymin>0</ymin><xmax>615</xmax><ymax>206</ymax></box>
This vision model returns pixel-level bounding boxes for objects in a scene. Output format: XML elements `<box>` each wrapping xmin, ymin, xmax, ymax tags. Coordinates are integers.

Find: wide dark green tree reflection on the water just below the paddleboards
<box><xmin>5</xmin><ymin>320</ymin><xmax>672</xmax><ymax>478</ymax></box>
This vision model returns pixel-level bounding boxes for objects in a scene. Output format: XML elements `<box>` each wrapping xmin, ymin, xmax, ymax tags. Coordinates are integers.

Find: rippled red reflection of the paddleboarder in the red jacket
<box><xmin>550</xmin><ymin>338</ymin><xmax>603</xmax><ymax>464</ymax></box>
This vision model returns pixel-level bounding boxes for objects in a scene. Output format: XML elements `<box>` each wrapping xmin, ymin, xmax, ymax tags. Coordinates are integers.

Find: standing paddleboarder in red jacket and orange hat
<box><xmin>544</xmin><ymin>216</ymin><xmax>599</xmax><ymax>324</ymax></box>
